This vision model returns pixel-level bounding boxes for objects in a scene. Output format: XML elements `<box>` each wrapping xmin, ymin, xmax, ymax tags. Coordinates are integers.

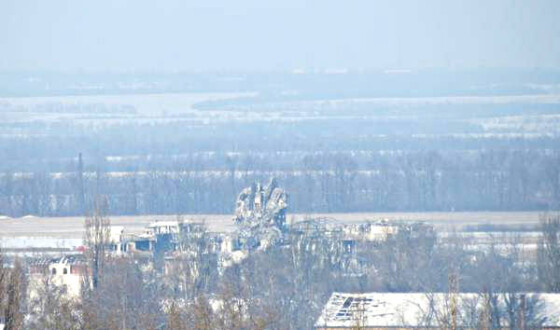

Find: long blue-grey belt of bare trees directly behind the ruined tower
<box><xmin>0</xmin><ymin>150</ymin><xmax>560</xmax><ymax>217</ymax></box>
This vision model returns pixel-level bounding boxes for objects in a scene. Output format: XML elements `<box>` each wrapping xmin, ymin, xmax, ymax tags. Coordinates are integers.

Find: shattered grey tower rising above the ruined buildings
<box><xmin>233</xmin><ymin>178</ymin><xmax>288</xmax><ymax>249</ymax></box>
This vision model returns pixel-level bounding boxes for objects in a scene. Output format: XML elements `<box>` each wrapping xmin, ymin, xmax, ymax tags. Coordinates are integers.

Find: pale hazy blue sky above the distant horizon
<box><xmin>0</xmin><ymin>0</ymin><xmax>560</xmax><ymax>71</ymax></box>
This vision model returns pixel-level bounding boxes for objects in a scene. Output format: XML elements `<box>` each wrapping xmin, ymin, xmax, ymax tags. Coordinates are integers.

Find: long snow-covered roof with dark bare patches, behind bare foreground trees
<box><xmin>315</xmin><ymin>292</ymin><xmax>560</xmax><ymax>328</ymax></box>
